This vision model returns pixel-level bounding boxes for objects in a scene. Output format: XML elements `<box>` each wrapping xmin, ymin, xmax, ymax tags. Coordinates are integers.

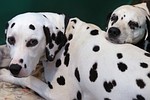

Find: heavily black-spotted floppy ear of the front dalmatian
<box><xmin>43</xmin><ymin>26</ymin><xmax>67</xmax><ymax>61</ymax></box>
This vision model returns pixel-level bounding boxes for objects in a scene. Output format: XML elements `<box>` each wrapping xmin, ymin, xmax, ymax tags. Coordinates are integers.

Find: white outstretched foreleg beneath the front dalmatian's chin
<box><xmin>0</xmin><ymin>69</ymin><xmax>54</xmax><ymax>100</ymax></box>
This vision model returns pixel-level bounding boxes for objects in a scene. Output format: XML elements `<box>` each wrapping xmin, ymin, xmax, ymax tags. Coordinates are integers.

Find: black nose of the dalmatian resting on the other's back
<box><xmin>108</xmin><ymin>27</ymin><xmax>121</xmax><ymax>38</ymax></box>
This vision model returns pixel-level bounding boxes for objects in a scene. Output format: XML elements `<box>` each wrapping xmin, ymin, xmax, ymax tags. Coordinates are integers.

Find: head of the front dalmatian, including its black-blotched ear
<box><xmin>5</xmin><ymin>13</ymin><xmax>67</xmax><ymax>77</ymax></box>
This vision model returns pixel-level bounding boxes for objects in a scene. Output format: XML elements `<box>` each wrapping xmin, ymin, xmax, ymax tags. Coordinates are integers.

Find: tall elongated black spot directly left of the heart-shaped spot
<box><xmin>89</xmin><ymin>63</ymin><xmax>98</xmax><ymax>82</ymax></box>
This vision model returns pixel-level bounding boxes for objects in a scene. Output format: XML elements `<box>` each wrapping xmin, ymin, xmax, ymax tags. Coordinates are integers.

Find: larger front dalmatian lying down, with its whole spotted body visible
<box><xmin>0</xmin><ymin>13</ymin><xmax>150</xmax><ymax>100</ymax></box>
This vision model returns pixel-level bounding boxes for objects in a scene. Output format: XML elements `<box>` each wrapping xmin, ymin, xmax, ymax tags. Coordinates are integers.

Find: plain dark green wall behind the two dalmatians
<box><xmin>0</xmin><ymin>0</ymin><xmax>135</xmax><ymax>44</ymax></box>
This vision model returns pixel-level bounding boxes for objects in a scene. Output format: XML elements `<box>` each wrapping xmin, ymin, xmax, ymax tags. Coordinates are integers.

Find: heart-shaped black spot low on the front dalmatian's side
<box><xmin>103</xmin><ymin>80</ymin><xmax>117</xmax><ymax>93</ymax></box>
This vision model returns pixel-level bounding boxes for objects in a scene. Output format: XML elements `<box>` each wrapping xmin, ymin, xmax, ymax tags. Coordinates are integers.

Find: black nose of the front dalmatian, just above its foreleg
<box><xmin>9</xmin><ymin>64</ymin><xmax>22</xmax><ymax>76</ymax></box>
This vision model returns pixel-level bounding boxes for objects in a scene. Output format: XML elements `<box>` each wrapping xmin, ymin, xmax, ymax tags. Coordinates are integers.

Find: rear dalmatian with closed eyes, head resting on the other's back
<box><xmin>106</xmin><ymin>3</ymin><xmax>150</xmax><ymax>52</ymax></box>
